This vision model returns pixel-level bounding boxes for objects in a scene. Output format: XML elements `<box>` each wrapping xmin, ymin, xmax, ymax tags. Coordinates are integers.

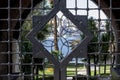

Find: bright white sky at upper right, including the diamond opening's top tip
<box><xmin>57</xmin><ymin>0</ymin><xmax>107</xmax><ymax>29</ymax></box>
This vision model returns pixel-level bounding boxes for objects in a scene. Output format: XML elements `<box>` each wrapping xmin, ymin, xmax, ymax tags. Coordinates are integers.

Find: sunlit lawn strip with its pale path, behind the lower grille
<box><xmin>39</xmin><ymin>65</ymin><xmax>110</xmax><ymax>76</ymax></box>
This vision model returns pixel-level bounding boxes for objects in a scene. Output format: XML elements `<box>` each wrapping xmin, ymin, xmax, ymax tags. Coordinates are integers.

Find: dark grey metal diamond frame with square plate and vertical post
<box><xmin>27</xmin><ymin>0</ymin><xmax>92</xmax><ymax>80</ymax></box>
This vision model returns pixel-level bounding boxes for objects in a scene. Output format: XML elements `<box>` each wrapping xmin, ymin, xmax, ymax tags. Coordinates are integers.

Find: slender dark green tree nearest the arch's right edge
<box><xmin>101</xmin><ymin>21</ymin><xmax>114</xmax><ymax>74</ymax></box>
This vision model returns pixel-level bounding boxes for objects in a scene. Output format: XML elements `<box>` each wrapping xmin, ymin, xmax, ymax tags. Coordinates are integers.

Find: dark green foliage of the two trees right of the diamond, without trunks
<box><xmin>88</xmin><ymin>17</ymin><xmax>114</xmax><ymax>57</ymax></box>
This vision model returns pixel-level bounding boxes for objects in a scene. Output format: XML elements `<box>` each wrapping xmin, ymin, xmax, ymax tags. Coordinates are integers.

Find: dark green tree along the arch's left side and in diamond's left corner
<box><xmin>20</xmin><ymin>1</ymin><xmax>51</xmax><ymax>80</ymax></box>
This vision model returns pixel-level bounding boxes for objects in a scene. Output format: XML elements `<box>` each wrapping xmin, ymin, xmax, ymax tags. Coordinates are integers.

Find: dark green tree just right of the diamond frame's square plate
<box><xmin>87</xmin><ymin>17</ymin><xmax>98</xmax><ymax>75</ymax></box>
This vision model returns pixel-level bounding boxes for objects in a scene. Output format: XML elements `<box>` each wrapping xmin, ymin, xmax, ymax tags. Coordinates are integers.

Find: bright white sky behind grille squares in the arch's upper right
<box><xmin>66</xmin><ymin>0</ymin><xmax>107</xmax><ymax>19</ymax></box>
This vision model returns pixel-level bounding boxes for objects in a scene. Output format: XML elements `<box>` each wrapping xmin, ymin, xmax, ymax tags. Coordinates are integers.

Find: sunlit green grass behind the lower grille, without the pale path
<box><xmin>39</xmin><ymin>65</ymin><xmax>110</xmax><ymax>76</ymax></box>
